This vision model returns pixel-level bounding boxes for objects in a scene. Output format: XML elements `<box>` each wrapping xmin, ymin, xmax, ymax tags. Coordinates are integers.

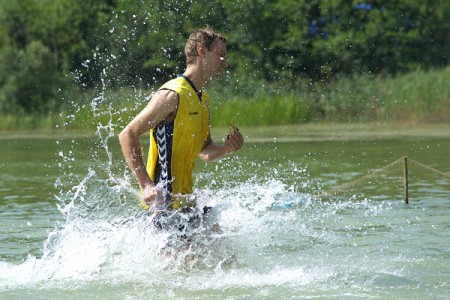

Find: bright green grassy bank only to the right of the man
<box><xmin>212</xmin><ymin>67</ymin><xmax>450</xmax><ymax>126</ymax></box>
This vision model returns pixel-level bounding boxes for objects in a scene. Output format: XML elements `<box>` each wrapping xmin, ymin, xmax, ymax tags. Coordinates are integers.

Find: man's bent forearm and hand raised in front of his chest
<box><xmin>198</xmin><ymin>126</ymin><xmax>244</xmax><ymax>161</ymax></box>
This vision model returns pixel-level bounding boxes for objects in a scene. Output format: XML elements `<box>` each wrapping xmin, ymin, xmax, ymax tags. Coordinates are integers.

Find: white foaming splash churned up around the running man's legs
<box><xmin>0</xmin><ymin>161</ymin><xmax>416</xmax><ymax>295</ymax></box>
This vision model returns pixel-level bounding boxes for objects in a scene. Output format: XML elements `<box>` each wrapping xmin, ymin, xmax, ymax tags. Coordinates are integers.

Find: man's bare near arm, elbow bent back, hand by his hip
<box><xmin>119</xmin><ymin>90</ymin><xmax>178</xmax><ymax>203</ymax></box>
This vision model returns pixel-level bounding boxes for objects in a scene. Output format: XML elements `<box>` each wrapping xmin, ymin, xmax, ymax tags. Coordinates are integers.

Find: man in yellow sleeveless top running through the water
<box><xmin>119</xmin><ymin>28</ymin><xmax>244</xmax><ymax>216</ymax></box>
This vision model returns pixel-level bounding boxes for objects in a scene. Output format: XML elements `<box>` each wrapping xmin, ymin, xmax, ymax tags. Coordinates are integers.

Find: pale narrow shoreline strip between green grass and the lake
<box><xmin>0</xmin><ymin>123</ymin><xmax>450</xmax><ymax>143</ymax></box>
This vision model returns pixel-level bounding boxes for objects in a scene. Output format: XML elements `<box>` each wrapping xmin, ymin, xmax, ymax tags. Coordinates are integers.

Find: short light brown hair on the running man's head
<box><xmin>184</xmin><ymin>27</ymin><xmax>228</xmax><ymax>65</ymax></box>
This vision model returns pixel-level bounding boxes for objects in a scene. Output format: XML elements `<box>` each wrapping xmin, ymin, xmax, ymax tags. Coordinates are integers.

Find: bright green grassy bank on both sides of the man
<box><xmin>0</xmin><ymin>67</ymin><xmax>450</xmax><ymax>130</ymax></box>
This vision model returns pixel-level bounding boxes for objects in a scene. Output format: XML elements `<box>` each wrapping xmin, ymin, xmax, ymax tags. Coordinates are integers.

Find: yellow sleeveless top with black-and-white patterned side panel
<box><xmin>146</xmin><ymin>75</ymin><xmax>210</xmax><ymax>209</ymax></box>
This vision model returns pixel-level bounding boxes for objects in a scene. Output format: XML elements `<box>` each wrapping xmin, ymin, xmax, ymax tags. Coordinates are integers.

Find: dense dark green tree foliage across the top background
<box><xmin>0</xmin><ymin>0</ymin><xmax>450</xmax><ymax>114</ymax></box>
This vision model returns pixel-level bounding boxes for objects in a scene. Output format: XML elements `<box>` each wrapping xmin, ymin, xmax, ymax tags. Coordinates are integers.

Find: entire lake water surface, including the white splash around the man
<box><xmin>0</xmin><ymin>132</ymin><xmax>450</xmax><ymax>299</ymax></box>
